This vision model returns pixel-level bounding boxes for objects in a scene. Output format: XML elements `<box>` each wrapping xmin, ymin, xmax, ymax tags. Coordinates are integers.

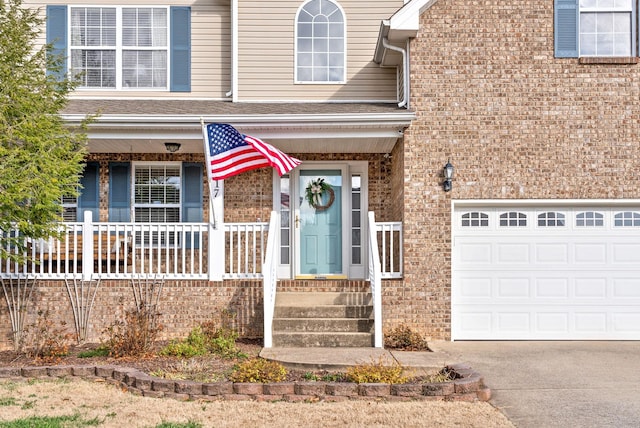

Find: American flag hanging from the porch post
<box><xmin>203</xmin><ymin>123</ymin><xmax>301</xmax><ymax>180</ymax></box>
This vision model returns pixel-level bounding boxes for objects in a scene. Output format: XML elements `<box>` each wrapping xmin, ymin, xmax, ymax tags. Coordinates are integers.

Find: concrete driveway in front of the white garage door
<box><xmin>430</xmin><ymin>342</ymin><xmax>640</xmax><ymax>428</ymax></box>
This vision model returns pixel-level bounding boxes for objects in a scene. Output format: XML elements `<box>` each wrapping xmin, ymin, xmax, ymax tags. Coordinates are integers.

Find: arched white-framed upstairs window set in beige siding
<box><xmin>295</xmin><ymin>0</ymin><xmax>346</xmax><ymax>83</ymax></box>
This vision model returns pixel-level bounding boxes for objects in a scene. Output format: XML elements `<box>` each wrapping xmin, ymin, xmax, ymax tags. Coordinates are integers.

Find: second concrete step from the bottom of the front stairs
<box><xmin>273</xmin><ymin>318</ymin><xmax>373</xmax><ymax>333</ymax></box>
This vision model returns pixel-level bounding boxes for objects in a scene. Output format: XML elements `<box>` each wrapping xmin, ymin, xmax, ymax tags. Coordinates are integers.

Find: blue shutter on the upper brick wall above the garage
<box><xmin>553</xmin><ymin>0</ymin><xmax>579</xmax><ymax>58</ymax></box>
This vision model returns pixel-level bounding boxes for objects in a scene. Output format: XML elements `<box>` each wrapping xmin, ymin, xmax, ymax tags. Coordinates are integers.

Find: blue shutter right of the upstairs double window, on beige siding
<box><xmin>170</xmin><ymin>6</ymin><xmax>191</xmax><ymax>92</ymax></box>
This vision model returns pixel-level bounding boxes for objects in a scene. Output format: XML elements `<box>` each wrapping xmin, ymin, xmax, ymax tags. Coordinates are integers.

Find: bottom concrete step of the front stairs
<box><xmin>273</xmin><ymin>332</ymin><xmax>374</xmax><ymax>348</ymax></box>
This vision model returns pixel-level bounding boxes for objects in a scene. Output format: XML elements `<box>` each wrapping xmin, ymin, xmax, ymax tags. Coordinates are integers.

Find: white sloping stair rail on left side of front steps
<box><xmin>262</xmin><ymin>211</ymin><xmax>280</xmax><ymax>348</ymax></box>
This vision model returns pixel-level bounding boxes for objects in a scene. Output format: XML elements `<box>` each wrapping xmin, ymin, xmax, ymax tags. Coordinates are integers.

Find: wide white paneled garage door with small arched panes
<box><xmin>452</xmin><ymin>205</ymin><xmax>640</xmax><ymax>340</ymax></box>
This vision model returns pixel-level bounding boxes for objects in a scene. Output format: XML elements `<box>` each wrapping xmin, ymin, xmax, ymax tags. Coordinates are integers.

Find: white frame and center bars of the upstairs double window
<box><xmin>66</xmin><ymin>4</ymin><xmax>172</xmax><ymax>92</ymax></box>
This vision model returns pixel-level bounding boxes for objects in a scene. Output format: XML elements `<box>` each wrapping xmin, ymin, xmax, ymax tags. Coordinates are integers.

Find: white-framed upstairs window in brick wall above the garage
<box><xmin>579</xmin><ymin>0</ymin><xmax>634</xmax><ymax>57</ymax></box>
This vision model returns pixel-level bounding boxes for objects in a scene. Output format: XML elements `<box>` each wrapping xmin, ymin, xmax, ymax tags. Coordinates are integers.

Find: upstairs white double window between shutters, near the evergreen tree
<box><xmin>69</xmin><ymin>7</ymin><xmax>169</xmax><ymax>89</ymax></box>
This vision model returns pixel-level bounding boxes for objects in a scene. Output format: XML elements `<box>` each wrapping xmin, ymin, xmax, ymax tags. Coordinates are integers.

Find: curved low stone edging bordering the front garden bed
<box><xmin>0</xmin><ymin>364</ymin><xmax>491</xmax><ymax>402</ymax></box>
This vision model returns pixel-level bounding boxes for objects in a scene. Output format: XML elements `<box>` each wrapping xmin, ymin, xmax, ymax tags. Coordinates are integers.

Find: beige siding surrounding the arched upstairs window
<box><xmin>238</xmin><ymin>0</ymin><xmax>403</xmax><ymax>102</ymax></box>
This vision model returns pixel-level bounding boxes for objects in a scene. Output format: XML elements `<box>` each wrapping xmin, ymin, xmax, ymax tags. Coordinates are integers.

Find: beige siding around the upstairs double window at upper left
<box><xmin>24</xmin><ymin>0</ymin><xmax>231</xmax><ymax>99</ymax></box>
